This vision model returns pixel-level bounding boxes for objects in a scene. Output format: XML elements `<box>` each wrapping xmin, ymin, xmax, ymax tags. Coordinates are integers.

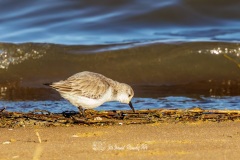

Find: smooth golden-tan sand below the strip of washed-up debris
<box><xmin>0</xmin><ymin>120</ymin><xmax>240</xmax><ymax>160</ymax></box>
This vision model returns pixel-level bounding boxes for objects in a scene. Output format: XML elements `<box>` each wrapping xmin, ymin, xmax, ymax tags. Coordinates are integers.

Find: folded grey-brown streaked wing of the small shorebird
<box><xmin>51</xmin><ymin>74</ymin><xmax>109</xmax><ymax>99</ymax></box>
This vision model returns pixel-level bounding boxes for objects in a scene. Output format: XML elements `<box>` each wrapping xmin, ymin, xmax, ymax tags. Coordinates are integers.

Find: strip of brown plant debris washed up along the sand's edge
<box><xmin>0</xmin><ymin>108</ymin><xmax>240</xmax><ymax>127</ymax></box>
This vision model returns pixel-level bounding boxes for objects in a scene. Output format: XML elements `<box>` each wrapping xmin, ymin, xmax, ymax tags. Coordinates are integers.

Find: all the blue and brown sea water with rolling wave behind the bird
<box><xmin>0</xmin><ymin>0</ymin><xmax>240</xmax><ymax>112</ymax></box>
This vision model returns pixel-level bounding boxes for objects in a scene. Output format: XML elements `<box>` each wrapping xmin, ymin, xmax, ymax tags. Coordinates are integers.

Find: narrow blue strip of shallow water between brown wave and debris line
<box><xmin>0</xmin><ymin>96</ymin><xmax>240</xmax><ymax>113</ymax></box>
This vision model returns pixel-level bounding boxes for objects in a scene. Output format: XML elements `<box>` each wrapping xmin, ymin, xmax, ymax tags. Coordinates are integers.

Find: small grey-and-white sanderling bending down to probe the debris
<box><xmin>46</xmin><ymin>71</ymin><xmax>135</xmax><ymax>118</ymax></box>
